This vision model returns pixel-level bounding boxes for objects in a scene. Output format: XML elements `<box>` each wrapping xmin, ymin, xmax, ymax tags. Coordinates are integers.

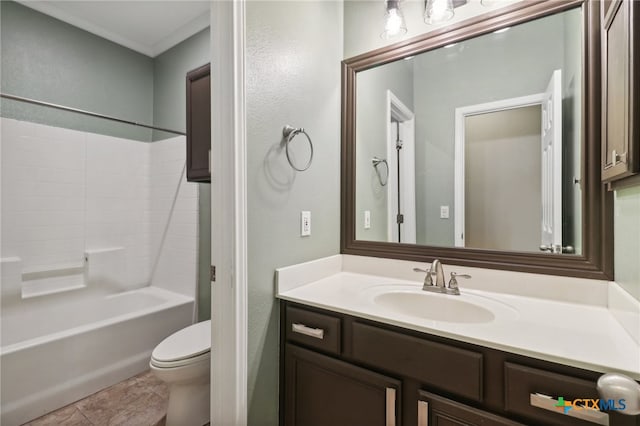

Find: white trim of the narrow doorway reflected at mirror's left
<box><xmin>386</xmin><ymin>90</ymin><xmax>416</xmax><ymax>243</ymax></box>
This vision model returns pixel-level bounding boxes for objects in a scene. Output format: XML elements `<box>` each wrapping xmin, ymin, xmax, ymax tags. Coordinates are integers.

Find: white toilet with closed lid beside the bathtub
<box><xmin>149</xmin><ymin>320</ymin><xmax>211</xmax><ymax>426</ymax></box>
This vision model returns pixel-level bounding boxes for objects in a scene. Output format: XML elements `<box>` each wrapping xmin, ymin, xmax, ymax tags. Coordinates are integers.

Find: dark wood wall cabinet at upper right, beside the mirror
<box><xmin>600</xmin><ymin>0</ymin><xmax>640</xmax><ymax>182</ymax></box>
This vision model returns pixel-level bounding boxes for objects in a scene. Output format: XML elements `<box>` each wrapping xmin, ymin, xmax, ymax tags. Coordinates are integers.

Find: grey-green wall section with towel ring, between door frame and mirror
<box><xmin>246</xmin><ymin>1</ymin><xmax>342</xmax><ymax>426</ymax></box>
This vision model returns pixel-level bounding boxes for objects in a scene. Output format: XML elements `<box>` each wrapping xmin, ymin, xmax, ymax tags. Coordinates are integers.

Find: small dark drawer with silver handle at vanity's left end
<box><xmin>285</xmin><ymin>306</ymin><xmax>341</xmax><ymax>354</ymax></box>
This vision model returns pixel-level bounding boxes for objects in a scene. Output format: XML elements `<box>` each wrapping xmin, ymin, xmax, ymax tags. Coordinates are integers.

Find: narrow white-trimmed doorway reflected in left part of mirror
<box><xmin>386</xmin><ymin>90</ymin><xmax>416</xmax><ymax>243</ymax></box>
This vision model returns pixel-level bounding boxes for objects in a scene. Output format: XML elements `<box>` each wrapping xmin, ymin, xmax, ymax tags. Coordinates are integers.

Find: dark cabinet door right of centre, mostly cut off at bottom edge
<box><xmin>418</xmin><ymin>391</ymin><xmax>523</xmax><ymax>426</ymax></box>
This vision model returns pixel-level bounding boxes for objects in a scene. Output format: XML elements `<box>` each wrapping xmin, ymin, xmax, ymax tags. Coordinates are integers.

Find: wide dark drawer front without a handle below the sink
<box><xmin>352</xmin><ymin>322</ymin><xmax>482</xmax><ymax>401</ymax></box>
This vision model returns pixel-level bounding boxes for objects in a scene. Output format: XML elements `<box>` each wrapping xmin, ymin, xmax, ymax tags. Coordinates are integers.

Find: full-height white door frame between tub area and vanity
<box><xmin>210</xmin><ymin>0</ymin><xmax>248</xmax><ymax>426</ymax></box>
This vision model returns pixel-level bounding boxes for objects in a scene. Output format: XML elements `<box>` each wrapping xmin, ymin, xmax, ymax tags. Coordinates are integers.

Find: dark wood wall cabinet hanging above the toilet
<box><xmin>187</xmin><ymin>64</ymin><xmax>211</xmax><ymax>182</ymax></box>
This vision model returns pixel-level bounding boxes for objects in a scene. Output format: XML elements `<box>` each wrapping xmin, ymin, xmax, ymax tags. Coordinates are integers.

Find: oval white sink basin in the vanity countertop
<box><xmin>373</xmin><ymin>291</ymin><xmax>495</xmax><ymax>323</ymax></box>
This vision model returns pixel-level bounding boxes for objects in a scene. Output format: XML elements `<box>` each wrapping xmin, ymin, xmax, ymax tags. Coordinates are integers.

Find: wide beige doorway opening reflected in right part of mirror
<box><xmin>455</xmin><ymin>102</ymin><xmax>543</xmax><ymax>251</ymax></box>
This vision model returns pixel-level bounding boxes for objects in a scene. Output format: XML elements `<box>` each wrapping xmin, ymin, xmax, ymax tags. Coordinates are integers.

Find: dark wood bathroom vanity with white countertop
<box><xmin>278</xmin><ymin>256</ymin><xmax>640</xmax><ymax>426</ymax></box>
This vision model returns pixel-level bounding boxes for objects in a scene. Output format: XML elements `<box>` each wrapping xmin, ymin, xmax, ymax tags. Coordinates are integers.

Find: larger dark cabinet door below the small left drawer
<box><xmin>284</xmin><ymin>345</ymin><xmax>400</xmax><ymax>426</ymax></box>
